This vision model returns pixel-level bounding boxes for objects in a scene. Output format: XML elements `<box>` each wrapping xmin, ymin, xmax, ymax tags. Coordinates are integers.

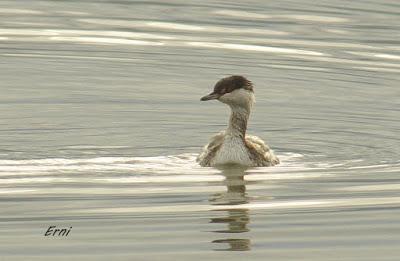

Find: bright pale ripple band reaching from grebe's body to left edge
<box><xmin>0</xmin><ymin>154</ymin><xmax>219</xmax><ymax>176</ymax></box>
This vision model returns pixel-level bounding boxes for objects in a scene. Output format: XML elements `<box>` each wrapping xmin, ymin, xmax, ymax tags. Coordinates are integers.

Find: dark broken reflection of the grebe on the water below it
<box><xmin>210</xmin><ymin>166</ymin><xmax>251</xmax><ymax>251</ymax></box>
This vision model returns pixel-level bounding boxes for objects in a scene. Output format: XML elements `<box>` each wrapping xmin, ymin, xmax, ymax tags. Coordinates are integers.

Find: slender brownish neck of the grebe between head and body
<box><xmin>226</xmin><ymin>106</ymin><xmax>250</xmax><ymax>140</ymax></box>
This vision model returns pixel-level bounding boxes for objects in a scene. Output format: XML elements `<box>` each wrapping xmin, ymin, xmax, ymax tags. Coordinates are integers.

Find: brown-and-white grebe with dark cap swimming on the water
<box><xmin>197</xmin><ymin>75</ymin><xmax>279</xmax><ymax>167</ymax></box>
